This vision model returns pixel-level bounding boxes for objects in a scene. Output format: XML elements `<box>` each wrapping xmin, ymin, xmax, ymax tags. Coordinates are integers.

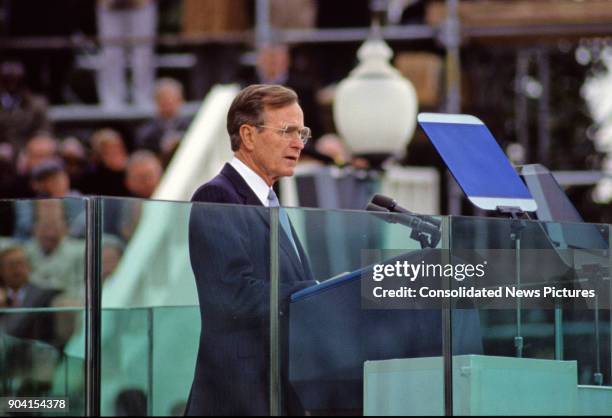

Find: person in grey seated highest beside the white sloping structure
<box><xmin>135</xmin><ymin>78</ymin><xmax>192</xmax><ymax>162</ymax></box>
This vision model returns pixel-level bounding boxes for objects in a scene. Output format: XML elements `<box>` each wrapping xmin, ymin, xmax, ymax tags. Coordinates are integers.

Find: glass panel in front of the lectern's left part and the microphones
<box><xmin>278</xmin><ymin>208</ymin><xmax>445</xmax><ymax>415</ymax></box>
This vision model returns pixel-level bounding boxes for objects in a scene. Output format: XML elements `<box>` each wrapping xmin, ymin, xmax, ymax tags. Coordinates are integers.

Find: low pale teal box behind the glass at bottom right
<box><xmin>364</xmin><ymin>355</ymin><xmax>586</xmax><ymax>416</ymax></box>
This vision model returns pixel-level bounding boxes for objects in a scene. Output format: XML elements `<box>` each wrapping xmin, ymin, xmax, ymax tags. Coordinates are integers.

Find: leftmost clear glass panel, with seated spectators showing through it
<box><xmin>0</xmin><ymin>199</ymin><xmax>86</xmax><ymax>416</ymax></box>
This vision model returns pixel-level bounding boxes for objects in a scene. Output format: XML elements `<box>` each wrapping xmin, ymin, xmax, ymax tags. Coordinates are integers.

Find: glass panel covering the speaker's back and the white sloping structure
<box><xmin>102</xmin><ymin>199</ymin><xmax>270</xmax><ymax>415</ymax></box>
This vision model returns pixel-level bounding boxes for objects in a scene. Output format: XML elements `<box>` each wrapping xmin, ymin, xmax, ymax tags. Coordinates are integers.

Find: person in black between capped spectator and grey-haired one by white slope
<box><xmin>82</xmin><ymin>128</ymin><xmax>128</xmax><ymax>196</ymax></box>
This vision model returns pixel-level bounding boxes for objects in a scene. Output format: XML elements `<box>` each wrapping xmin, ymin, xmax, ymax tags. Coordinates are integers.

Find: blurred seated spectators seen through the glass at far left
<box><xmin>0</xmin><ymin>200</ymin><xmax>125</xmax><ymax>348</ymax></box>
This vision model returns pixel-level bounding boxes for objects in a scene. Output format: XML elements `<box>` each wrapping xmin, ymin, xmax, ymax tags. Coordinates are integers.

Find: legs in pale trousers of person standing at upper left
<box><xmin>96</xmin><ymin>0</ymin><xmax>157</xmax><ymax>109</ymax></box>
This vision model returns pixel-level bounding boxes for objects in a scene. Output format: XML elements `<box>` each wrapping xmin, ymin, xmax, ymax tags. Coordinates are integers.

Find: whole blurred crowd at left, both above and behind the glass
<box><xmin>0</xmin><ymin>63</ymin><xmax>178</xmax><ymax>364</ymax></box>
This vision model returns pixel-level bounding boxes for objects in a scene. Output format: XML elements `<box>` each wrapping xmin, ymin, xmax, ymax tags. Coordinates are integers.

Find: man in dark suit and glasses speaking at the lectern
<box><xmin>186</xmin><ymin>85</ymin><xmax>315</xmax><ymax>415</ymax></box>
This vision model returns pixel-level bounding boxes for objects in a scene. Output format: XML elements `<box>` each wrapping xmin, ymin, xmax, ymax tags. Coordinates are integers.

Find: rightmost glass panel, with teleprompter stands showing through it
<box><xmin>451</xmin><ymin>217</ymin><xmax>612</xmax><ymax>415</ymax></box>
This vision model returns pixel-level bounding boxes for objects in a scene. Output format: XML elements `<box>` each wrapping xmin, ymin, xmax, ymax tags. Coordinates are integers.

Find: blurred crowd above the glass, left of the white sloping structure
<box><xmin>0</xmin><ymin>62</ymin><xmax>191</xmax><ymax>203</ymax></box>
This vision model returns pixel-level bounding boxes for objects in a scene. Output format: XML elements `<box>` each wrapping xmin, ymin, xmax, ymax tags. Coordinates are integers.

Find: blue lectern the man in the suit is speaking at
<box><xmin>289</xmin><ymin>251</ymin><xmax>482</xmax><ymax>411</ymax></box>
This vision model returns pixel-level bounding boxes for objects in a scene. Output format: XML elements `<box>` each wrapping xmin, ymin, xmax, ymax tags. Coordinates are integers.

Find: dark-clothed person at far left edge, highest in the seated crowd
<box><xmin>0</xmin><ymin>61</ymin><xmax>51</xmax><ymax>156</ymax></box>
